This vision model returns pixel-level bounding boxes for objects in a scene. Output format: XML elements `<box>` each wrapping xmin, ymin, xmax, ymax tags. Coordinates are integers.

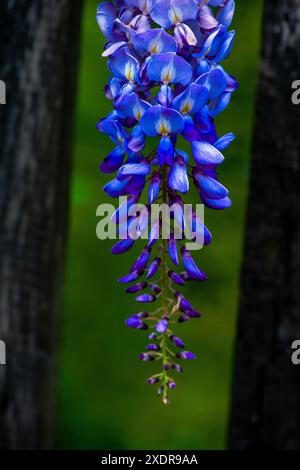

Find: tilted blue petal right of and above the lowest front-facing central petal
<box><xmin>172</xmin><ymin>83</ymin><xmax>208</xmax><ymax>115</ymax></box>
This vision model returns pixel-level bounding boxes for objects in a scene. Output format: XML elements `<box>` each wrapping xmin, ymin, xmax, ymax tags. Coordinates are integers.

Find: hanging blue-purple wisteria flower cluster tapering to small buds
<box><xmin>97</xmin><ymin>0</ymin><xmax>237</xmax><ymax>404</ymax></box>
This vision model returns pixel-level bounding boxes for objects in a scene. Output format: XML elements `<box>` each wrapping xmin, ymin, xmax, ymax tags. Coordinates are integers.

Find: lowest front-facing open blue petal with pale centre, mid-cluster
<box><xmin>140</xmin><ymin>106</ymin><xmax>184</xmax><ymax>137</ymax></box>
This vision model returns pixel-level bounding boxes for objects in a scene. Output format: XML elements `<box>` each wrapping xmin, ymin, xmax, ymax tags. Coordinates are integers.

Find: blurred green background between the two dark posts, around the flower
<box><xmin>56</xmin><ymin>0</ymin><xmax>263</xmax><ymax>450</ymax></box>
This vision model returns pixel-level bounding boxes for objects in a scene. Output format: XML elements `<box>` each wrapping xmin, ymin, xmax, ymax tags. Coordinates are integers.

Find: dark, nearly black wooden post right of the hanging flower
<box><xmin>229</xmin><ymin>0</ymin><xmax>300</xmax><ymax>449</ymax></box>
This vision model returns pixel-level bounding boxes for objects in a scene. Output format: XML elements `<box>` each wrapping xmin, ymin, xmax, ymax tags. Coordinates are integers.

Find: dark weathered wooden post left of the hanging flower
<box><xmin>0</xmin><ymin>0</ymin><xmax>81</xmax><ymax>449</ymax></box>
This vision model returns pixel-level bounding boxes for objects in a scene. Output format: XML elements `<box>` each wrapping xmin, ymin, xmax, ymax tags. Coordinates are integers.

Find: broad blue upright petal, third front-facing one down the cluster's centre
<box><xmin>146</xmin><ymin>52</ymin><xmax>193</xmax><ymax>86</ymax></box>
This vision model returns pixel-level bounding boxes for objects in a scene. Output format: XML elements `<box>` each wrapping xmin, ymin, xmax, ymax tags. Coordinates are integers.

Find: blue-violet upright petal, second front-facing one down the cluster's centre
<box><xmin>132</xmin><ymin>28</ymin><xmax>178</xmax><ymax>54</ymax></box>
